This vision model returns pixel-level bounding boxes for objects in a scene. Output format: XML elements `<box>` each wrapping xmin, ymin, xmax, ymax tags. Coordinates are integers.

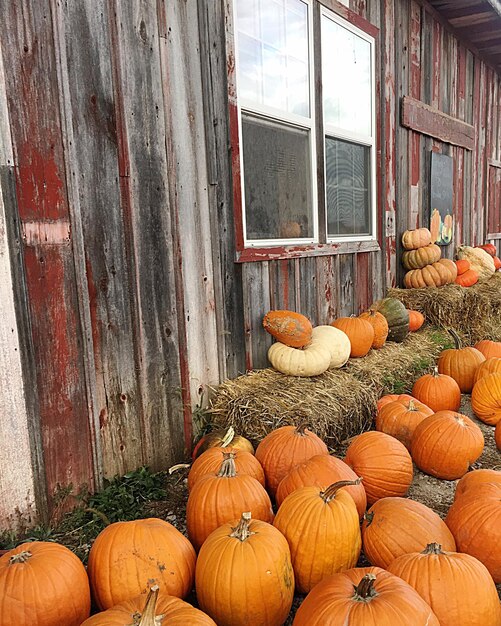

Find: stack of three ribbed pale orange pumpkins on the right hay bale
<box><xmin>402</xmin><ymin>228</ymin><xmax>457</xmax><ymax>289</ymax></box>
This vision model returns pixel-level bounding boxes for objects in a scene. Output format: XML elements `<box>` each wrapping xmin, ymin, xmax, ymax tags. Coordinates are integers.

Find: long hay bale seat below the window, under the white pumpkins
<box><xmin>209</xmin><ymin>329</ymin><xmax>449</xmax><ymax>447</ymax></box>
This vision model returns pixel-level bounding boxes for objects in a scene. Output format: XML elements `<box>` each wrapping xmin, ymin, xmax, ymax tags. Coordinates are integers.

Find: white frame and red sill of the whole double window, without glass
<box><xmin>227</xmin><ymin>0</ymin><xmax>380</xmax><ymax>254</ymax></box>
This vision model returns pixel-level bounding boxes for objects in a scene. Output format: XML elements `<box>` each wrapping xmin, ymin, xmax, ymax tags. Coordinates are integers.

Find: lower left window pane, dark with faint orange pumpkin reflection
<box><xmin>242</xmin><ymin>115</ymin><xmax>313</xmax><ymax>240</ymax></box>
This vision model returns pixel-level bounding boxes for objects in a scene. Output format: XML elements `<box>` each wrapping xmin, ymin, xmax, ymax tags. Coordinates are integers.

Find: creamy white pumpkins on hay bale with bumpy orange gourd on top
<box><xmin>268</xmin><ymin>326</ymin><xmax>351</xmax><ymax>376</ymax></box>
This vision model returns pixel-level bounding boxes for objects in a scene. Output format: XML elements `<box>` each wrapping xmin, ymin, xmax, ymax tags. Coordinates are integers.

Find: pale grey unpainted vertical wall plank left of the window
<box><xmin>157</xmin><ymin>0</ymin><xmax>219</xmax><ymax>444</ymax></box>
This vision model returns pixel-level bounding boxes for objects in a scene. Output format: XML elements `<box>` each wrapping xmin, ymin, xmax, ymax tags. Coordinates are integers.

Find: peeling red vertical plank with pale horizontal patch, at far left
<box><xmin>1</xmin><ymin>0</ymin><xmax>93</xmax><ymax>507</ymax></box>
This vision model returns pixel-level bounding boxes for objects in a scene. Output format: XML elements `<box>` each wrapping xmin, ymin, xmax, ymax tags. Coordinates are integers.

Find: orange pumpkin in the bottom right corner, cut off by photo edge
<box><xmin>388</xmin><ymin>543</ymin><xmax>501</xmax><ymax>626</ymax></box>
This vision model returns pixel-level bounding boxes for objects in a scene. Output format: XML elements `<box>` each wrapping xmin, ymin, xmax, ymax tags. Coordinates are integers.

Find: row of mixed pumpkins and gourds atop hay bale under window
<box><xmin>263</xmin><ymin>298</ymin><xmax>424</xmax><ymax>376</ymax></box>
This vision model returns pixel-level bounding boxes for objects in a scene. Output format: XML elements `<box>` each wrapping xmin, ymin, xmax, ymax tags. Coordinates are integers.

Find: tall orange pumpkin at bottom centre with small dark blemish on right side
<box><xmin>194</xmin><ymin>512</ymin><xmax>294</xmax><ymax>626</ymax></box>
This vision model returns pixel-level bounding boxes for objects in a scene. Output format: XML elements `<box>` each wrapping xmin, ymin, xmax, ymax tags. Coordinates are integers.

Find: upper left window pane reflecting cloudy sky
<box><xmin>237</xmin><ymin>0</ymin><xmax>310</xmax><ymax>117</ymax></box>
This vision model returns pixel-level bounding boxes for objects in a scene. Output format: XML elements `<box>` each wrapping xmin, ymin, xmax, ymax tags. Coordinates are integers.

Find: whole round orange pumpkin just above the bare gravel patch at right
<box><xmin>411</xmin><ymin>411</ymin><xmax>484</xmax><ymax>480</ymax></box>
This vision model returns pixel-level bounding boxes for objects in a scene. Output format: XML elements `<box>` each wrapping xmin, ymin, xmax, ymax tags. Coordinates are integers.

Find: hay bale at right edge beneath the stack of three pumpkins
<box><xmin>388</xmin><ymin>273</ymin><xmax>501</xmax><ymax>344</ymax></box>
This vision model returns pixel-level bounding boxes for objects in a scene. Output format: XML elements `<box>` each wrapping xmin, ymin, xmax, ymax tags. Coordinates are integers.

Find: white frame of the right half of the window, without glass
<box><xmin>320</xmin><ymin>7</ymin><xmax>377</xmax><ymax>243</ymax></box>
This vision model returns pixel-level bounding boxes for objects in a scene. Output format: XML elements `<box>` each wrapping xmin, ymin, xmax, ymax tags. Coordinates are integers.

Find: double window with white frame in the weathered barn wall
<box><xmin>233</xmin><ymin>0</ymin><xmax>377</xmax><ymax>258</ymax></box>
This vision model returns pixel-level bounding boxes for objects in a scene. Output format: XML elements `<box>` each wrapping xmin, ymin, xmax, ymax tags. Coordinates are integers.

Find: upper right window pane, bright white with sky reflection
<box><xmin>322</xmin><ymin>16</ymin><xmax>372</xmax><ymax>136</ymax></box>
